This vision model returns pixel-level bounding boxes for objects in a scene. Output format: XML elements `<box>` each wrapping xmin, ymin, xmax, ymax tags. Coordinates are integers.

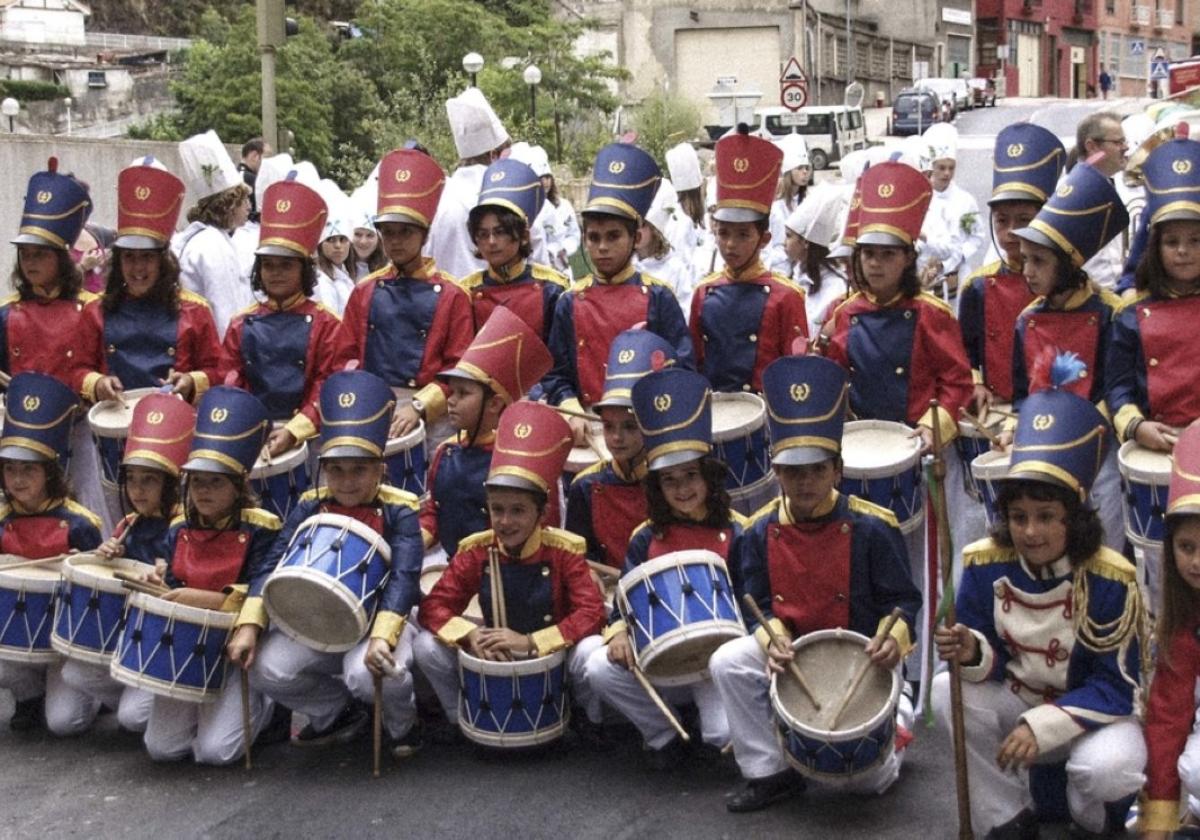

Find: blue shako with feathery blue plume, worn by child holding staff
<box><xmin>1008</xmin><ymin>353</ymin><xmax>1109</xmax><ymax>500</ymax></box>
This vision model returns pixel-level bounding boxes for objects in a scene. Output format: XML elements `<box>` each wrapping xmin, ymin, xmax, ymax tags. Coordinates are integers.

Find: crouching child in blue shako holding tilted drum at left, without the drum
<box><xmin>229</xmin><ymin>371</ymin><xmax>422</xmax><ymax>758</ymax></box>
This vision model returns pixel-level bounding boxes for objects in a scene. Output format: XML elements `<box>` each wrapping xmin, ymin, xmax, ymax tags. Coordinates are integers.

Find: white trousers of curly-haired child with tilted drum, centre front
<box><xmin>587</xmin><ymin>644</ymin><xmax>730</xmax><ymax>750</ymax></box>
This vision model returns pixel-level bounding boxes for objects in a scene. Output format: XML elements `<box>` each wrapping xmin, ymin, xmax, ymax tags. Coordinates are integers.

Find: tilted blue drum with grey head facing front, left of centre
<box><xmin>263</xmin><ymin>514</ymin><xmax>391</xmax><ymax>653</ymax></box>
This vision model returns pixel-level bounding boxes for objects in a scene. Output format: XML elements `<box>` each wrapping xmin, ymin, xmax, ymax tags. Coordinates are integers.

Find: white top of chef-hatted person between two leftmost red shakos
<box><xmin>170</xmin><ymin>222</ymin><xmax>254</xmax><ymax>338</ymax></box>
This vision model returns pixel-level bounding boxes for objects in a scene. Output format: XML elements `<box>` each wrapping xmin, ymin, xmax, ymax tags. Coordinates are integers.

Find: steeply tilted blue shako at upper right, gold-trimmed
<box><xmin>1015</xmin><ymin>162</ymin><xmax>1129</xmax><ymax>269</ymax></box>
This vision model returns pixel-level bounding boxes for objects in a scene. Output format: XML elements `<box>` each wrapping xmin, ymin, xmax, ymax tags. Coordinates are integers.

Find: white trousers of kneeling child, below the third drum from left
<box><xmin>143</xmin><ymin>665</ymin><xmax>275</xmax><ymax>764</ymax></box>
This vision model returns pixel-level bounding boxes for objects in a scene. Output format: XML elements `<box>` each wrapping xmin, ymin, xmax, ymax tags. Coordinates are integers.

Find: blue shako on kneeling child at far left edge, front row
<box><xmin>0</xmin><ymin>374</ymin><xmax>79</xmax><ymax>467</ymax></box>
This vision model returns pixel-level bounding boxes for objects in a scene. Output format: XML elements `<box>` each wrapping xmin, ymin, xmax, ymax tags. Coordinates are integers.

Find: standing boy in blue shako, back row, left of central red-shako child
<box><xmin>544</xmin><ymin>143</ymin><xmax>692</xmax><ymax>446</ymax></box>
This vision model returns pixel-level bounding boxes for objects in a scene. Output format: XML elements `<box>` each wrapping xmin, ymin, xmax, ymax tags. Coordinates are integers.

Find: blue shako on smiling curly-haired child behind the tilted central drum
<box><xmin>632</xmin><ymin>367</ymin><xmax>713</xmax><ymax>469</ymax></box>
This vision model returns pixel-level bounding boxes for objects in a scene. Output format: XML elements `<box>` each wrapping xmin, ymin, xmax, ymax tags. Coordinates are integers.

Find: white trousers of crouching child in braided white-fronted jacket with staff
<box><xmin>932</xmin><ymin>671</ymin><xmax>1146</xmax><ymax>835</ymax></box>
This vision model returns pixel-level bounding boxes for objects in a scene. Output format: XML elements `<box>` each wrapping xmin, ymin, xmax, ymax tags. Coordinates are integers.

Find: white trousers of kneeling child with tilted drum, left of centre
<box><xmin>250</xmin><ymin>623</ymin><xmax>416</xmax><ymax>738</ymax></box>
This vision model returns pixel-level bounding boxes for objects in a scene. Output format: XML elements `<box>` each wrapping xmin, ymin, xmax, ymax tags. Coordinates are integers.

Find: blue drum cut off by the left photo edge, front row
<box><xmin>0</xmin><ymin>554</ymin><xmax>61</xmax><ymax>664</ymax></box>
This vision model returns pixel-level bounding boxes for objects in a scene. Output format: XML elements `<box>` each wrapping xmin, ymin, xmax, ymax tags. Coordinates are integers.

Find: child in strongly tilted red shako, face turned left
<box><xmin>421</xmin><ymin>306</ymin><xmax>559</xmax><ymax>558</ymax></box>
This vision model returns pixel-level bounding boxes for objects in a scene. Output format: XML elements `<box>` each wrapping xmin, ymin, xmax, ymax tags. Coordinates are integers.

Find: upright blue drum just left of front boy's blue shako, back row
<box><xmin>713</xmin><ymin>392</ymin><xmax>779</xmax><ymax>516</ymax></box>
